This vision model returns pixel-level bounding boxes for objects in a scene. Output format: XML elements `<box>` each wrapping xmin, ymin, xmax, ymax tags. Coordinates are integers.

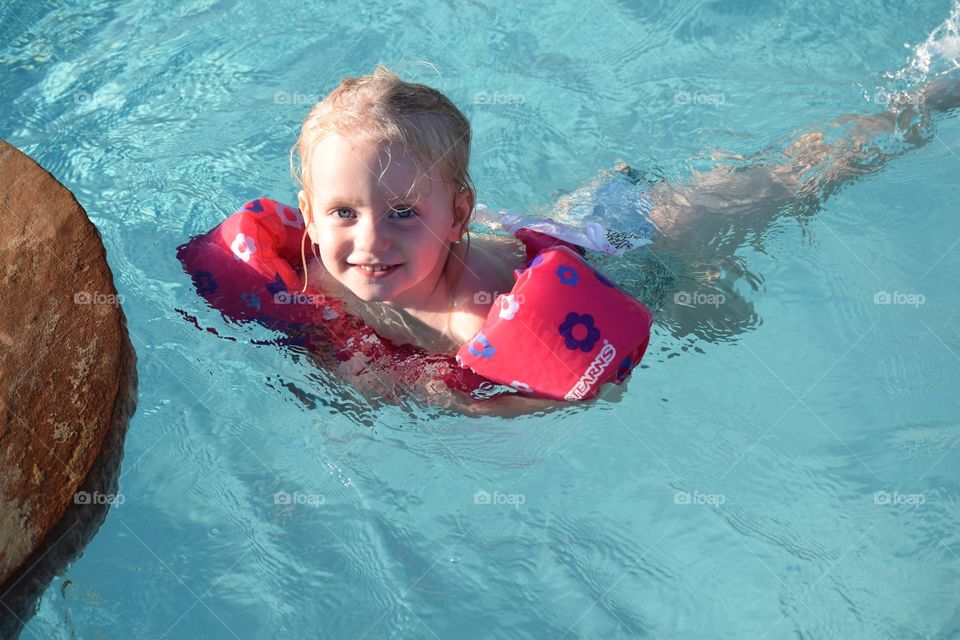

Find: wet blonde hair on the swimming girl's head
<box><xmin>290</xmin><ymin>64</ymin><xmax>476</xmax><ymax>291</ymax></box>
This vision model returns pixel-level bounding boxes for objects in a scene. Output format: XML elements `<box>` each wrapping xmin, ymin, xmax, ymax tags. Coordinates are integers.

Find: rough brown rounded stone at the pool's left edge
<box><xmin>0</xmin><ymin>141</ymin><xmax>137</xmax><ymax>596</ymax></box>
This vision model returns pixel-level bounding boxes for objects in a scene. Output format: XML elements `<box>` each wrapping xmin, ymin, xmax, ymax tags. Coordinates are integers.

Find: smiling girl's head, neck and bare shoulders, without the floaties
<box><xmin>295</xmin><ymin>77</ymin><xmax>523</xmax><ymax>353</ymax></box>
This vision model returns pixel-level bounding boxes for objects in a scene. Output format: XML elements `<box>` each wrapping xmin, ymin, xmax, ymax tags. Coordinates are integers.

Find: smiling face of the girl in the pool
<box><xmin>299</xmin><ymin>134</ymin><xmax>470</xmax><ymax>309</ymax></box>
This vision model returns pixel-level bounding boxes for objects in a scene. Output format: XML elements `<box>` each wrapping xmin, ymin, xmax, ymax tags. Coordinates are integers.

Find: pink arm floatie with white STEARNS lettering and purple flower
<box><xmin>456</xmin><ymin>235</ymin><xmax>653</xmax><ymax>400</ymax></box>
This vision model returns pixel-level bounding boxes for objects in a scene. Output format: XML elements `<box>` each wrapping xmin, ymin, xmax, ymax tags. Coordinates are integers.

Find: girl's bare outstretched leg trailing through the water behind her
<box><xmin>650</xmin><ymin>80</ymin><xmax>960</xmax><ymax>251</ymax></box>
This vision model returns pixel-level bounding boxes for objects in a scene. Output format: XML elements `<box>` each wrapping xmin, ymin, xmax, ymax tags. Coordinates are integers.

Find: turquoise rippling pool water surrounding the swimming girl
<box><xmin>0</xmin><ymin>0</ymin><xmax>960</xmax><ymax>639</ymax></box>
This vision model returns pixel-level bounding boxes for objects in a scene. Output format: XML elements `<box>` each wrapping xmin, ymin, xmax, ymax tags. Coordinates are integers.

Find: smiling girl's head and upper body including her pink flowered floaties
<box><xmin>179</xmin><ymin>66</ymin><xmax>653</xmax><ymax>405</ymax></box>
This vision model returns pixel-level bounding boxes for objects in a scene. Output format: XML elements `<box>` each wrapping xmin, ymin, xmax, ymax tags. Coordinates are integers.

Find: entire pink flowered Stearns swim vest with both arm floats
<box><xmin>177</xmin><ymin>198</ymin><xmax>653</xmax><ymax>400</ymax></box>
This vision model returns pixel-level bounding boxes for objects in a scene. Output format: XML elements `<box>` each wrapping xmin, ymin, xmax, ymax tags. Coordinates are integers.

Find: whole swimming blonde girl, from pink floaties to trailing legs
<box><xmin>180</xmin><ymin>66</ymin><xmax>956</xmax><ymax>410</ymax></box>
